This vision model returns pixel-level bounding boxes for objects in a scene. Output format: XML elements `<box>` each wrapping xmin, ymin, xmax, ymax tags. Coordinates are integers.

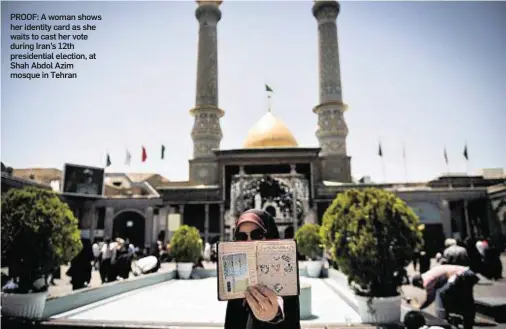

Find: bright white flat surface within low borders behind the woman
<box><xmin>54</xmin><ymin>278</ymin><xmax>360</xmax><ymax>326</ymax></box>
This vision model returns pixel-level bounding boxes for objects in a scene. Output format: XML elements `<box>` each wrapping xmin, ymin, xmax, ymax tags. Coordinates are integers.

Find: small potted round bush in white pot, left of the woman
<box><xmin>170</xmin><ymin>225</ymin><xmax>202</xmax><ymax>279</ymax></box>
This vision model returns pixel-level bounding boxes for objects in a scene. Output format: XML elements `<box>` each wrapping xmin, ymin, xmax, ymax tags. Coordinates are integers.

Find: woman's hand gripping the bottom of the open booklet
<box><xmin>245</xmin><ymin>285</ymin><xmax>279</xmax><ymax>322</ymax></box>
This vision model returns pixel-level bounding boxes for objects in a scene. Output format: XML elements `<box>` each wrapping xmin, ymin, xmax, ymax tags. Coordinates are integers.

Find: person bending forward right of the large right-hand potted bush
<box><xmin>411</xmin><ymin>265</ymin><xmax>479</xmax><ymax>329</ymax></box>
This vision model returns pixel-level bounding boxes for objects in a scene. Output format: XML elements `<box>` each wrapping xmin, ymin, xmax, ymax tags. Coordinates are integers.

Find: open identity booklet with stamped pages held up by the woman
<box><xmin>217</xmin><ymin>240</ymin><xmax>299</xmax><ymax>301</ymax></box>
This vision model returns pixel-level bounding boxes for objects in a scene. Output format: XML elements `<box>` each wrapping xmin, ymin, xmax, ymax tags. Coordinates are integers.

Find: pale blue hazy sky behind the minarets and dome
<box><xmin>1</xmin><ymin>1</ymin><xmax>506</xmax><ymax>182</ymax></box>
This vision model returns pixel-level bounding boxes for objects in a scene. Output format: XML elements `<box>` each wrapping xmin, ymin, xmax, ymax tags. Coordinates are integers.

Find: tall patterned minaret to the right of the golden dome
<box><xmin>313</xmin><ymin>1</ymin><xmax>351</xmax><ymax>182</ymax></box>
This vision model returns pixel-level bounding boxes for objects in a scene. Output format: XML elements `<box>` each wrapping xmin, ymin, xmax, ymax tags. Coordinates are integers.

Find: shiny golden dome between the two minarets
<box><xmin>244</xmin><ymin>111</ymin><xmax>297</xmax><ymax>148</ymax></box>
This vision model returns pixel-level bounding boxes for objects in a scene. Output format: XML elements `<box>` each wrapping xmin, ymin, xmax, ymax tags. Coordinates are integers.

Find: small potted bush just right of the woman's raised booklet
<box><xmin>295</xmin><ymin>223</ymin><xmax>323</xmax><ymax>278</ymax></box>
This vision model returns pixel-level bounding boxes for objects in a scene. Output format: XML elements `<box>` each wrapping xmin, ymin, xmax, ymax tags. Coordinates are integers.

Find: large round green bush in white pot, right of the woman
<box><xmin>321</xmin><ymin>188</ymin><xmax>422</xmax><ymax>323</ymax></box>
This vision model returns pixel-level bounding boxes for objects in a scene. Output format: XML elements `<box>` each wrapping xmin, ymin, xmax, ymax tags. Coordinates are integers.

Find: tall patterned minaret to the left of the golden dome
<box><xmin>190</xmin><ymin>1</ymin><xmax>224</xmax><ymax>184</ymax></box>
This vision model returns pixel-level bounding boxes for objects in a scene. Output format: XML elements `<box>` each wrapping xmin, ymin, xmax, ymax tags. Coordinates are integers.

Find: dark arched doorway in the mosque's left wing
<box><xmin>112</xmin><ymin>210</ymin><xmax>146</xmax><ymax>248</ymax></box>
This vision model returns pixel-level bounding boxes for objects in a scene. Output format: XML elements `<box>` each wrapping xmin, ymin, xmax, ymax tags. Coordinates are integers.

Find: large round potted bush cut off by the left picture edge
<box><xmin>1</xmin><ymin>187</ymin><xmax>82</xmax><ymax>319</ymax></box>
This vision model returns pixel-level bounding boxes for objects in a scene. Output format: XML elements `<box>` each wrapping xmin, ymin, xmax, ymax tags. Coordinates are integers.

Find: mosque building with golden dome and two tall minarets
<box><xmin>4</xmin><ymin>1</ymin><xmax>506</xmax><ymax>255</ymax></box>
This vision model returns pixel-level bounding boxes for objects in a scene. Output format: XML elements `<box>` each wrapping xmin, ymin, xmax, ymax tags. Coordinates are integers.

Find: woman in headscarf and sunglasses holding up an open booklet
<box><xmin>225</xmin><ymin>209</ymin><xmax>300</xmax><ymax>329</ymax></box>
